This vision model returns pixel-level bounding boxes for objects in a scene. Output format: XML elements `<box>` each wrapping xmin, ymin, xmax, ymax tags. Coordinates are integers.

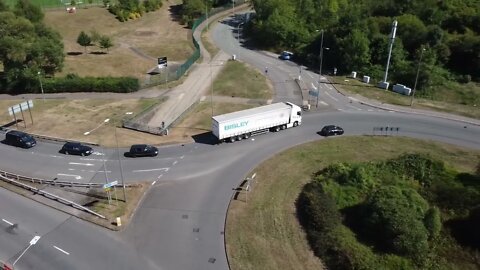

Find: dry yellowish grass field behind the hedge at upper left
<box><xmin>45</xmin><ymin>1</ymin><xmax>193</xmax><ymax>79</ymax></box>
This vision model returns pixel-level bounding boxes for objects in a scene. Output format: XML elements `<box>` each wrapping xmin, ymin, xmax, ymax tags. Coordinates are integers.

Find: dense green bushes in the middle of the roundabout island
<box><xmin>297</xmin><ymin>154</ymin><xmax>480</xmax><ymax>269</ymax></box>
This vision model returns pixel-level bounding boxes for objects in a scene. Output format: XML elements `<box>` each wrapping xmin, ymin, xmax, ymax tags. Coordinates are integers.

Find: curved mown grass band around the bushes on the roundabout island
<box><xmin>226</xmin><ymin>136</ymin><xmax>480</xmax><ymax>270</ymax></box>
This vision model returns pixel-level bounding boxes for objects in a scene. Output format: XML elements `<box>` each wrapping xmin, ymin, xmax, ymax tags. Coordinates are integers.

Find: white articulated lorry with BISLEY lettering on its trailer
<box><xmin>212</xmin><ymin>102</ymin><xmax>302</xmax><ymax>142</ymax></box>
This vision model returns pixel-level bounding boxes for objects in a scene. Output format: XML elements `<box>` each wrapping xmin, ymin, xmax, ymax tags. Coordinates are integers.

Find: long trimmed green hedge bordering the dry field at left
<box><xmin>43</xmin><ymin>75</ymin><xmax>140</xmax><ymax>93</ymax></box>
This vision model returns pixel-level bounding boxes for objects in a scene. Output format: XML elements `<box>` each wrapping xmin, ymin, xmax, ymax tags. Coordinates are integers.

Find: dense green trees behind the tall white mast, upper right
<box><xmin>247</xmin><ymin>0</ymin><xmax>480</xmax><ymax>94</ymax></box>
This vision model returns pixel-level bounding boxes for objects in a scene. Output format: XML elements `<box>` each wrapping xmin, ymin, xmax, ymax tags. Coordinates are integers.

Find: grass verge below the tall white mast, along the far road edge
<box><xmin>329</xmin><ymin>76</ymin><xmax>480</xmax><ymax>119</ymax></box>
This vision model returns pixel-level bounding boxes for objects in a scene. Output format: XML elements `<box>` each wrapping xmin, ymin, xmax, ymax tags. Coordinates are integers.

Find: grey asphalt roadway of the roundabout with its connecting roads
<box><xmin>0</xmin><ymin>11</ymin><xmax>480</xmax><ymax>270</ymax></box>
